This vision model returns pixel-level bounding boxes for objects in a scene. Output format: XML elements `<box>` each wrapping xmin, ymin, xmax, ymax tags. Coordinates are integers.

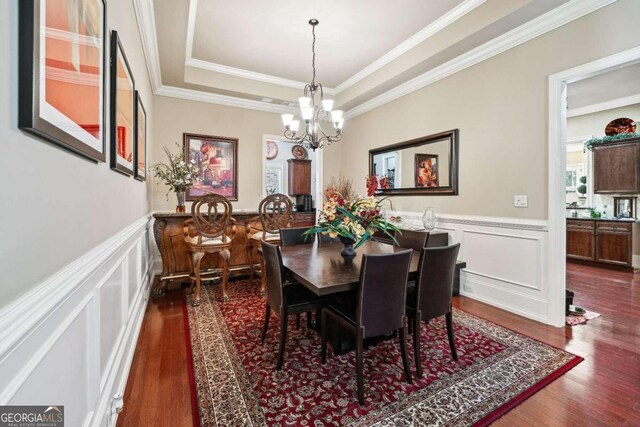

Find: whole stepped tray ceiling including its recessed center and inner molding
<box><xmin>150</xmin><ymin>0</ymin><xmax>592</xmax><ymax>111</ymax></box>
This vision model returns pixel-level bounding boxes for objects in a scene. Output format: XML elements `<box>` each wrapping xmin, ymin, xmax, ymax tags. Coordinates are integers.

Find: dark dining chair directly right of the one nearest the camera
<box><xmin>407</xmin><ymin>243</ymin><xmax>460</xmax><ymax>378</ymax></box>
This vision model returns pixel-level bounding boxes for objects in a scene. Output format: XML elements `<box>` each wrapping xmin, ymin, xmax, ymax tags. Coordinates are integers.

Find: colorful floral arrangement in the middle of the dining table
<box><xmin>305</xmin><ymin>179</ymin><xmax>398</xmax><ymax>257</ymax></box>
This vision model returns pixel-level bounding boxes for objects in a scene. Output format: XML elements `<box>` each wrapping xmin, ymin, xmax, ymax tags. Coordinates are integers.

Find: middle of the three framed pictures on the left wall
<box><xmin>110</xmin><ymin>31</ymin><xmax>136</xmax><ymax>175</ymax></box>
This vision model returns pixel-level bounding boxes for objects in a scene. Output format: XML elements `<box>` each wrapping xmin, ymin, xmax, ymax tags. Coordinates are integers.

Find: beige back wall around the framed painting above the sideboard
<box><xmin>150</xmin><ymin>96</ymin><xmax>282</xmax><ymax>211</ymax></box>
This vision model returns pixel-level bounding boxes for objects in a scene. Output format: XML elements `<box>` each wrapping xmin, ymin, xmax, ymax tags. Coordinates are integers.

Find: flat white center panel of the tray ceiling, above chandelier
<box><xmin>193</xmin><ymin>0</ymin><xmax>462</xmax><ymax>87</ymax></box>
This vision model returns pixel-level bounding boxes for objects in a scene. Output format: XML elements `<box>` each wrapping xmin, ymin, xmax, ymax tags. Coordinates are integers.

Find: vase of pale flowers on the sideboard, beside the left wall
<box><xmin>151</xmin><ymin>143</ymin><xmax>200</xmax><ymax>212</ymax></box>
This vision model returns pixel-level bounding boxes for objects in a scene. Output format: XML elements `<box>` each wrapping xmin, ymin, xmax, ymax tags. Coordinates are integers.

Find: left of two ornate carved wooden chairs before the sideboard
<box><xmin>183</xmin><ymin>194</ymin><xmax>235</xmax><ymax>306</ymax></box>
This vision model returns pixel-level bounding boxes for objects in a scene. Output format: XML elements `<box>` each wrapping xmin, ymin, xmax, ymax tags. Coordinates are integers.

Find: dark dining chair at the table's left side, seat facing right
<box><xmin>261</xmin><ymin>241</ymin><xmax>324</xmax><ymax>371</ymax></box>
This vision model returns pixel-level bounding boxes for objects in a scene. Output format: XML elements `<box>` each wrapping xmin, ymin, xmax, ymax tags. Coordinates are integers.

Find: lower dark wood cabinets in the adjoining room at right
<box><xmin>567</xmin><ymin>219</ymin><xmax>634</xmax><ymax>267</ymax></box>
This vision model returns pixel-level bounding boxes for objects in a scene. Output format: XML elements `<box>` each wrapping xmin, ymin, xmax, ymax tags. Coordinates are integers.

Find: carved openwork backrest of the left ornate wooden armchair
<box><xmin>191</xmin><ymin>194</ymin><xmax>233</xmax><ymax>239</ymax></box>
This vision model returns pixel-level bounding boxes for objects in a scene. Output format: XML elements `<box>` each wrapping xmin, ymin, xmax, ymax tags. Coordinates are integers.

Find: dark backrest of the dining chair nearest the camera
<box><xmin>356</xmin><ymin>249</ymin><xmax>413</xmax><ymax>338</ymax></box>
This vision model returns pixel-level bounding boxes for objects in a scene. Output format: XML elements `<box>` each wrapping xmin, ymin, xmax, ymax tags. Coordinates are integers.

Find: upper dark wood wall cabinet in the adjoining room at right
<box><xmin>593</xmin><ymin>139</ymin><xmax>640</xmax><ymax>194</ymax></box>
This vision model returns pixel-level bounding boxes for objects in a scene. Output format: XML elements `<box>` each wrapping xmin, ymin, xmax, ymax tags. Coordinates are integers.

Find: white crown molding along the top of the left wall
<box><xmin>133</xmin><ymin>0</ymin><xmax>162</xmax><ymax>93</ymax></box>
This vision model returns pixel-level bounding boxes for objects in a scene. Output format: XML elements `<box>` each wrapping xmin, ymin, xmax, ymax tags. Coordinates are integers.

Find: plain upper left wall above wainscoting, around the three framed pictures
<box><xmin>0</xmin><ymin>0</ymin><xmax>154</xmax><ymax>307</ymax></box>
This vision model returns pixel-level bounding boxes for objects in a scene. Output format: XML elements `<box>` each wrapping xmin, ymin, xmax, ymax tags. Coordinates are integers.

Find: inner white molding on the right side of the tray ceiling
<box><xmin>335</xmin><ymin>0</ymin><xmax>486</xmax><ymax>94</ymax></box>
